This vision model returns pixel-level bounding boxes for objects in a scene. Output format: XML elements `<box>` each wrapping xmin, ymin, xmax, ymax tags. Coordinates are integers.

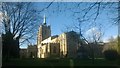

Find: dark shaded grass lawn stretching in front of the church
<box><xmin>3</xmin><ymin>59</ymin><xmax>118</xmax><ymax>67</ymax></box>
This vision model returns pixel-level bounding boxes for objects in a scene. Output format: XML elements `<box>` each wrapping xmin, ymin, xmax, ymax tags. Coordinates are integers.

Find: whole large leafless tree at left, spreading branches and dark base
<box><xmin>0</xmin><ymin>2</ymin><xmax>52</xmax><ymax>58</ymax></box>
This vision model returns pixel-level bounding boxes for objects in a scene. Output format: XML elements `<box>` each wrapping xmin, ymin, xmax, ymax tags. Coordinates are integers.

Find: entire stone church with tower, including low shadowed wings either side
<box><xmin>20</xmin><ymin>16</ymin><xmax>103</xmax><ymax>58</ymax></box>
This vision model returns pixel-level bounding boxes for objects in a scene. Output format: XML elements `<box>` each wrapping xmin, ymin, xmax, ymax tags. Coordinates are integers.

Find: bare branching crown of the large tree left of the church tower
<box><xmin>1</xmin><ymin>2</ymin><xmax>52</xmax><ymax>44</ymax></box>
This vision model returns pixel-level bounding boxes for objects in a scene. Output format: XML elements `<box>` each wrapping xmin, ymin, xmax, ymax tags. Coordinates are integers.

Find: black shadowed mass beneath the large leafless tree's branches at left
<box><xmin>2</xmin><ymin>32</ymin><xmax>19</xmax><ymax>60</ymax></box>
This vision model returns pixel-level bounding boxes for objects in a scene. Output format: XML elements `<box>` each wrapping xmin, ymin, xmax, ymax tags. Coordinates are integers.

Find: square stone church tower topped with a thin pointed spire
<box><xmin>37</xmin><ymin>15</ymin><xmax>51</xmax><ymax>44</ymax></box>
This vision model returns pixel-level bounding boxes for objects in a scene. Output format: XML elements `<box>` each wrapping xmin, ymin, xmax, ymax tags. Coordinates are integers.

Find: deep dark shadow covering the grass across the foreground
<box><xmin>2</xmin><ymin>59</ymin><xmax>118</xmax><ymax>68</ymax></box>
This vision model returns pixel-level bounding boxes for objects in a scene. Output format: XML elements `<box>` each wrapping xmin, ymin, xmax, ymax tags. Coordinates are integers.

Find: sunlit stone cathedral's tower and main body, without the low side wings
<box><xmin>37</xmin><ymin>16</ymin><xmax>79</xmax><ymax>58</ymax></box>
